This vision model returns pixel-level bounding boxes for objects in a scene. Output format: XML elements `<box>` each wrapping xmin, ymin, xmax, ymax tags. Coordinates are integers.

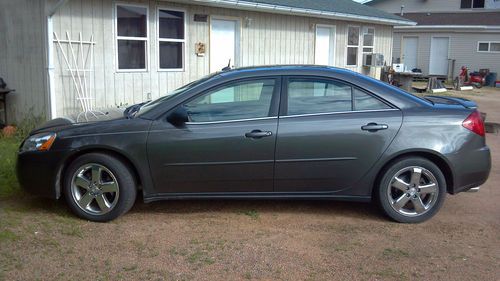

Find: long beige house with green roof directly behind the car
<box><xmin>0</xmin><ymin>0</ymin><xmax>414</xmax><ymax>121</ymax></box>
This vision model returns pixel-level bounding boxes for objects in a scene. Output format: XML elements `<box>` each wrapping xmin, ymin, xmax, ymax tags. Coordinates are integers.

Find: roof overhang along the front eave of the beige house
<box><xmin>166</xmin><ymin>0</ymin><xmax>417</xmax><ymax>26</ymax></box>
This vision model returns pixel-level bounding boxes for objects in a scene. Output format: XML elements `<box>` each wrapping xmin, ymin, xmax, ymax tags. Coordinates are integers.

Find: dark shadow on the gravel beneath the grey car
<box><xmin>2</xmin><ymin>191</ymin><xmax>386</xmax><ymax>221</ymax></box>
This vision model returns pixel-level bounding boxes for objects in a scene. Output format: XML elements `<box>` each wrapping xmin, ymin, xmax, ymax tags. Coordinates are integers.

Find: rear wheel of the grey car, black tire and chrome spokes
<box><xmin>375</xmin><ymin>157</ymin><xmax>446</xmax><ymax>223</ymax></box>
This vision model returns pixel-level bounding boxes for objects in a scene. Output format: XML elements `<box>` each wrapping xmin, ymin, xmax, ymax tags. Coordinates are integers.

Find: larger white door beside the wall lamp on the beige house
<box><xmin>209</xmin><ymin>18</ymin><xmax>240</xmax><ymax>72</ymax></box>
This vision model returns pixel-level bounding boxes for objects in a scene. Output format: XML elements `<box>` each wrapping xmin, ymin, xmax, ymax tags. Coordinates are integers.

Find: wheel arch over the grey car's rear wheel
<box><xmin>372</xmin><ymin>150</ymin><xmax>454</xmax><ymax>196</ymax></box>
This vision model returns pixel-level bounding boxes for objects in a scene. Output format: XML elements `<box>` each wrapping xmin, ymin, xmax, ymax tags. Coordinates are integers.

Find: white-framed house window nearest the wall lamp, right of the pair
<box><xmin>156</xmin><ymin>6</ymin><xmax>188</xmax><ymax>72</ymax></box>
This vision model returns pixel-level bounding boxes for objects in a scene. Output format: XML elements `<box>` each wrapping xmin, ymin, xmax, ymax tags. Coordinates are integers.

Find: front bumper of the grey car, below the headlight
<box><xmin>16</xmin><ymin>151</ymin><xmax>69</xmax><ymax>199</ymax></box>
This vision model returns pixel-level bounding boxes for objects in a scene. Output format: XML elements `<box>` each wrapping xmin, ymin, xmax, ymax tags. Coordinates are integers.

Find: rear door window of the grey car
<box><xmin>288</xmin><ymin>79</ymin><xmax>352</xmax><ymax>115</ymax></box>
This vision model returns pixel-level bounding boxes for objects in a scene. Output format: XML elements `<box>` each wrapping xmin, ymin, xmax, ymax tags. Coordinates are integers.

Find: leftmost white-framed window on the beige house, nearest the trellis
<box><xmin>116</xmin><ymin>5</ymin><xmax>148</xmax><ymax>70</ymax></box>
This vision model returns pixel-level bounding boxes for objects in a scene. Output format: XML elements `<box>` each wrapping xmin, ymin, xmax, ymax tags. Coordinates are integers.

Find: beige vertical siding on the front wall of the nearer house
<box><xmin>47</xmin><ymin>0</ymin><xmax>393</xmax><ymax>116</ymax></box>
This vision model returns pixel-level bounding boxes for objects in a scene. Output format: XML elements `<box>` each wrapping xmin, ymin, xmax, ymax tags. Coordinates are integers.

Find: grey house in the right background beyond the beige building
<box><xmin>366</xmin><ymin>0</ymin><xmax>500</xmax><ymax>78</ymax></box>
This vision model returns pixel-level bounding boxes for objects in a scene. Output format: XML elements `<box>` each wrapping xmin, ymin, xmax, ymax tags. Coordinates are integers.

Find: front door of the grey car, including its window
<box><xmin>148</xmin><ymin>78</ymin><xmax>281</xmax><ymax>194</ymax></box>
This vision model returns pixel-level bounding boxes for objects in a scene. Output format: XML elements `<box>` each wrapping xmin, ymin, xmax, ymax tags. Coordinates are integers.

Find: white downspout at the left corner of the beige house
<box><xmin>45</xmin><ymin>0</ymin><xmax>68</xmax><ymax>119</ymax></box>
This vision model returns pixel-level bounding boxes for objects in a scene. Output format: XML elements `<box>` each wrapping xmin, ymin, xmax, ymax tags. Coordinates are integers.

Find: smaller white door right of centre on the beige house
<box><xmin>314</xmin><ymin>25</ymin><xmax>335</xmax><ymax>65</ymax></box>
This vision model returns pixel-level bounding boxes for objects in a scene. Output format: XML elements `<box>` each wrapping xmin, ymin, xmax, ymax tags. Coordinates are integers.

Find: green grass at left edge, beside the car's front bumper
<box><xmin>0</xmin><ymin>137</ymin><xmax>20</xmax><ymax>198</ymax></box>
